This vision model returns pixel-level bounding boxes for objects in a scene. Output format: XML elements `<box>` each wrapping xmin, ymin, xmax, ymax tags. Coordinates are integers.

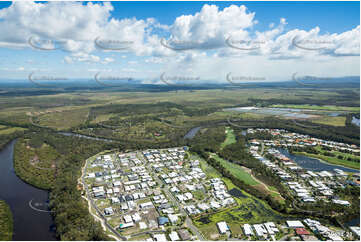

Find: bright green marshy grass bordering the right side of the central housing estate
<box><xmin>194</xmin><ymin>157</ymin><xmax>283</xmax><ymax>240</ymax></box>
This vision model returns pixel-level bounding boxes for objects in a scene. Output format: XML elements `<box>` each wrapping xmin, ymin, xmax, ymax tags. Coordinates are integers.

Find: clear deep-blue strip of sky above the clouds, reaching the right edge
<box><xmin>104</xmin><ymin>1</ymin><xmax>360</xmax><ymax>32</ymax></box>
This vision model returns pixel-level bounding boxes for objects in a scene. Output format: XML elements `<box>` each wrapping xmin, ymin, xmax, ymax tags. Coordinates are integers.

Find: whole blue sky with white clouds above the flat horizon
<box><xmin>0</xmin><ymin>1</ymin><xmax>360</xmax><ymax>84</ymax></box>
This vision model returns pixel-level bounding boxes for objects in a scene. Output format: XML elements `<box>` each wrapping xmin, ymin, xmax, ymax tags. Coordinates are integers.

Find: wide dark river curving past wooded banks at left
<box><xmin>0</xmin><ymin>140</ymin><xmax>56</xmax><ymax>241</ymax></box>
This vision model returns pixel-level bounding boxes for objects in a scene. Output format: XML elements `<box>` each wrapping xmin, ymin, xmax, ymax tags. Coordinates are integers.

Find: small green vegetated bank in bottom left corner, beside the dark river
<box><xmin>0</xmin><ymin>200</ymin><xmax>13</xmax><ymax>241</ymax></box>
